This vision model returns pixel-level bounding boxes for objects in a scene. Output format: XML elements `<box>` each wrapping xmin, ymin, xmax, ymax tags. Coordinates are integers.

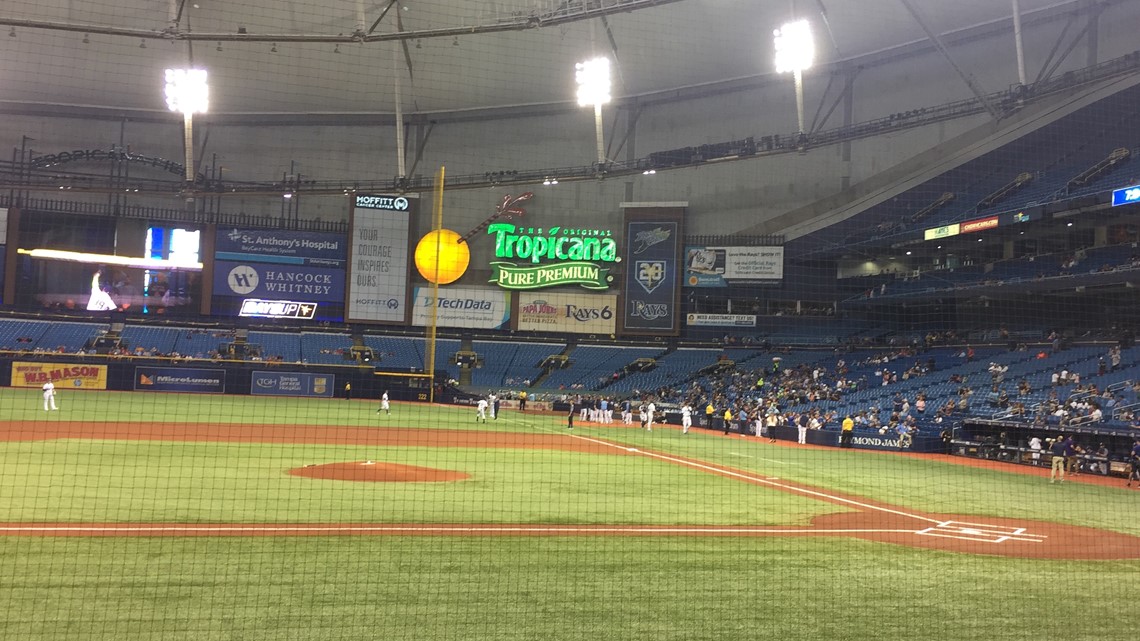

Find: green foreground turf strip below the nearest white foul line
<box><xmin>0</xmin><ymin>537</ymin><xmax>1140</xmax><ymax>641</ymax></box>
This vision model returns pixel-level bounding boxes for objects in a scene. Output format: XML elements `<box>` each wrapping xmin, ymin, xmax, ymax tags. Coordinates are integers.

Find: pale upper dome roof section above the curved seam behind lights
<box><xmin>0</xmin><ymin>0</ymin><xmax>1123</xmax><ymax>114</ymax></box>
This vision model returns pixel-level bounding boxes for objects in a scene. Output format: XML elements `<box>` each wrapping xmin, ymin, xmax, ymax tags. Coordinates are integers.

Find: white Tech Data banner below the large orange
<box><xmin>412</xmin><ymin>286</ymin><xmax>511</xmax><ymax>330</ymax></box>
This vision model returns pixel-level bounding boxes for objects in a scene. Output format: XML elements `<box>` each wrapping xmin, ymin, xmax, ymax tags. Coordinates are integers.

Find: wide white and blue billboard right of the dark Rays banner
<box><xmin>685</xmin><ymin>246</ymin><xmax>783</xmax><ymax>287</ymax></box>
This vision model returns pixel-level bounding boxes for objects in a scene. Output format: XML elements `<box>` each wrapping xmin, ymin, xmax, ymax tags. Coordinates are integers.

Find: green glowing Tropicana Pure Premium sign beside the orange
<box><xmin>487</xmin><ymin>222</ymin><xmax>621</xmax><ymax>290</ymax></box>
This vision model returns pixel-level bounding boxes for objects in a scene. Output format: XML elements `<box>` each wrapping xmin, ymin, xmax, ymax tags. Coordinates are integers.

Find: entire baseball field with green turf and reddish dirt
<box><xmin>0</xmin><ymin>389</ymin><xmax>1140</xmax><ymax>641</ymax></box>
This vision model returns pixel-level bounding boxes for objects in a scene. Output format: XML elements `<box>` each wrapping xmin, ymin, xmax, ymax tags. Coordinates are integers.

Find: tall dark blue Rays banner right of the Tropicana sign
<box><xmin>621</xmin><ymin>213</ymin><xmax>684</xmax><ymax>334</ymax></box>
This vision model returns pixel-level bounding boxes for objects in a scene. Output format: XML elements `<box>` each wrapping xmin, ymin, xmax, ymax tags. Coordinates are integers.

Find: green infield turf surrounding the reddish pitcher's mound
<box><xmin>0</xmin><ymin>439</ymin><xmax>842</xmax><ymax>525</ymax></box>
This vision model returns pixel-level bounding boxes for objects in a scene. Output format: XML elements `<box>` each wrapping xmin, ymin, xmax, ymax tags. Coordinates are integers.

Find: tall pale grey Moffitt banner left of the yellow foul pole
<box><xmin>344</xmin><ymin>196</ymin><xmax>416</xmax><ymax>323</ymax></box>
